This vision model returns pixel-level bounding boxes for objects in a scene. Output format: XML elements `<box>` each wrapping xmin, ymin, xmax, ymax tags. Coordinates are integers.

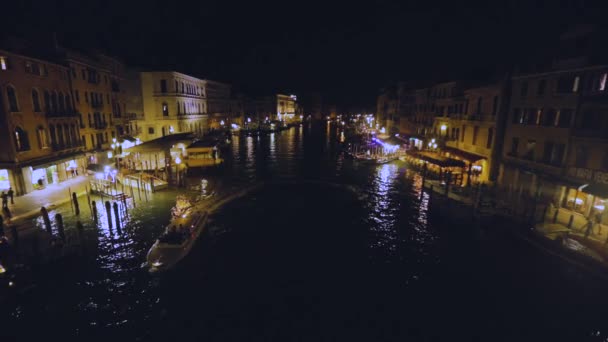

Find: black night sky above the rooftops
<box><xmin>0</xmin><ymin>0</ymin><xmax>608</xmax><ymax>106</ymax></box>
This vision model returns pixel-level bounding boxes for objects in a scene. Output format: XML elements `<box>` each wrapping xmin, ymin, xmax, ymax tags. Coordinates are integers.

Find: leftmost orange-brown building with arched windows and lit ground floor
<box><xmin>0</xmin><ymin>50</ymin><xmax>86</xmax><ymax>195</ymax></box>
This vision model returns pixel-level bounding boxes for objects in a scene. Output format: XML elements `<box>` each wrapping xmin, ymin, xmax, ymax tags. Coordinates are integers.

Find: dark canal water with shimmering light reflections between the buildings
<box><xmin>0</xmin><ymin>123</ymin><xmax>608</xmax><ymax>341</ymax></box>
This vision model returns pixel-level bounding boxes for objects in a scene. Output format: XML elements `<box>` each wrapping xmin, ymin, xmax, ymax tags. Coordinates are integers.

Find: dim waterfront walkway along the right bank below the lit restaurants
<box><xmin>424</xmin><ymin>175</ymin><xmax>608</xmax><ymax>271</ymax></box>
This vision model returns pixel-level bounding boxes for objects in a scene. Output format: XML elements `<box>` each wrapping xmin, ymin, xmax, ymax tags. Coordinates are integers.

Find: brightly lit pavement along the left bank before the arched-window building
<box><xmin>5</xmin><ymin>176</ymin><xmax>89</xmax><ymax>222</ymax></box>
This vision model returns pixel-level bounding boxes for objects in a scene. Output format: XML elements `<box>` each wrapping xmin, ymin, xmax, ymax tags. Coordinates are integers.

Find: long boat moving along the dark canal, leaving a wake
<box><xmin>147</xmin><ymin>207</ymin><xmax>208</xmax><ymax>272</ymax></box>
